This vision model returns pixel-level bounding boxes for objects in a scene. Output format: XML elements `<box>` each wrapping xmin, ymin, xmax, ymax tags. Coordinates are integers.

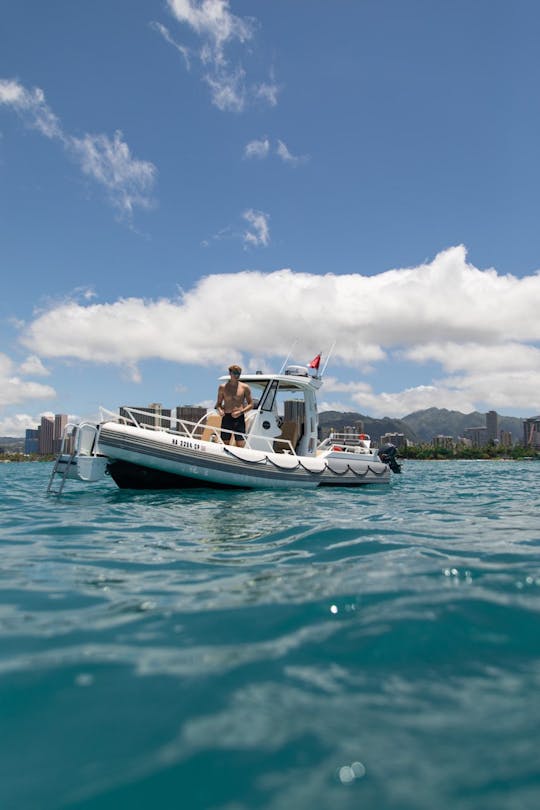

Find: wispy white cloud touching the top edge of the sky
<box><xmin>163</xmin><ymin>0</ymin><xmax>279</xmax><ymax>112</ymax></box>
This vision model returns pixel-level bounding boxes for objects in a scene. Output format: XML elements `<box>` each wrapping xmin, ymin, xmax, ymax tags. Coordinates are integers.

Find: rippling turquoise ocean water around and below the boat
<box><xmin>0</xmin><ymin>461</ymin><xmax>540</xmax><ymax>810</ymax></box>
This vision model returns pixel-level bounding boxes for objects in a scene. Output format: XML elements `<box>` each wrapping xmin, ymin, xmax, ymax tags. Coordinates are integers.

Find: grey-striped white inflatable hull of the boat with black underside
<box><xmin>99</xmin><ymin>423</ymin><xmax>390</xmax><ymax>489</ymax></box>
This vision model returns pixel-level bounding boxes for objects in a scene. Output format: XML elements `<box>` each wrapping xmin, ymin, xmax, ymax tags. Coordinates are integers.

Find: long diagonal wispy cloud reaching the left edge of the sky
<box><xmin>0</xmin><ymin>79</ymin><xmax>157</xmax><ymax>220</ymax></box>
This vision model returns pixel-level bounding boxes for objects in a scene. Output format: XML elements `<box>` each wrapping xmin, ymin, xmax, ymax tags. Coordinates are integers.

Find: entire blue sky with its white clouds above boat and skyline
<box><xmin>0</xmin><ymin>0</ymin><xmax>540</xmax><ymax>435</ymax></box>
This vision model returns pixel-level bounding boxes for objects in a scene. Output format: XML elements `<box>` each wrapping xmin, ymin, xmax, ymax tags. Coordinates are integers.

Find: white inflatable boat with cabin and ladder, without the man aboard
<box><xmin>47</xmin><ymin>366</ymin><xmax>400</xmax><ymax>494</ymax></box>
